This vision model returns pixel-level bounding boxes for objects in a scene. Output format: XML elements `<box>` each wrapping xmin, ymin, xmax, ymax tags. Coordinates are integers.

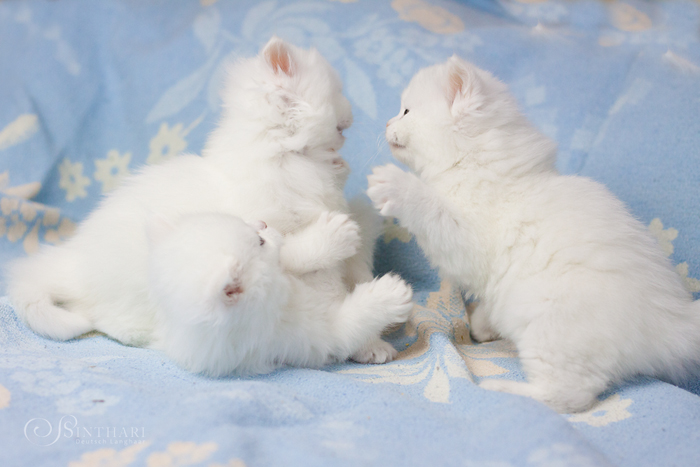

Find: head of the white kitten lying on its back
<box><xmin>148</xmin><ymin>213</ymin><xmax>282</xmax><ymax>324</ymax></box>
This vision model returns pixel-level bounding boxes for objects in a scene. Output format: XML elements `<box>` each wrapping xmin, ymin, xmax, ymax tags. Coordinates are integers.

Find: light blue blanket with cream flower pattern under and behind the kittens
<box><xmin>0</xmin><ymin>0</ymin><xmax>700</xmax><ymax>467</ymax></box>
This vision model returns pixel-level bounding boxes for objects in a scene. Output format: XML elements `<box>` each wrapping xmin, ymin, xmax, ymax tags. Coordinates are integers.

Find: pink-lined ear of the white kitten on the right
<box><xmin>445</xmin><ymin>55</ymin><xmax>483</xmax><ymax>116</ymax></box>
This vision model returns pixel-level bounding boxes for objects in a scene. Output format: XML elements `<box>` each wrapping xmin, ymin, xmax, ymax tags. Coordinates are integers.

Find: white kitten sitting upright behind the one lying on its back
<box><xmin>7</xmin><ymin>38</ymin><xmax>396</xmax><ymax>362</ymax></box>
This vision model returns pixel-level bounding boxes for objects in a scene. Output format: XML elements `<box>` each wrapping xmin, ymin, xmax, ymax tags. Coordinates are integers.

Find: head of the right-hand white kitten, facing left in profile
<box><xmin>386</xmin><ymin>56</ymin><xmax>554</xmax><ymax>179</ymax></box>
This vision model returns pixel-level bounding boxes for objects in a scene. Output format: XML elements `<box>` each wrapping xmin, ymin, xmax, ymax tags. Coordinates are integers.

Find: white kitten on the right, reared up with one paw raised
<box><xmin>367</xmin><ymin>57</ymin><xmax>700</xmax><ymax>412</ymax></box>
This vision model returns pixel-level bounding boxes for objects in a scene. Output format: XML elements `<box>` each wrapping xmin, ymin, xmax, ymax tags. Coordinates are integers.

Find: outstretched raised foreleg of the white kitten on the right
<box><xmin>367</xmin><ymin>164</ymin><xmax>484</xmax><ymax>284</ymax></box>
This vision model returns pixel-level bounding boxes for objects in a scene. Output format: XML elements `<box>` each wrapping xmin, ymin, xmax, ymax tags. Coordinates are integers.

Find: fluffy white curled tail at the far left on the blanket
<box><xmin>7</xmin><ymin>248</ymin><xmax>94</xmax><ymax>341</ymax></box>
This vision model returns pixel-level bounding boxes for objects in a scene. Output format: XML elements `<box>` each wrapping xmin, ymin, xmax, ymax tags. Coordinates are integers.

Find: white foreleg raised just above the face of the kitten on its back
<box><xmin>280</xmin><ymin>211</ymin><xmax>360</xmax><ymax>275</ymax></box>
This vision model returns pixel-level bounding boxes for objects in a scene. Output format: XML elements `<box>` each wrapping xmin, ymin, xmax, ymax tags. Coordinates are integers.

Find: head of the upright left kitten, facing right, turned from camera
<box><xmin>216</xmin><ymin>37</ymin><xmax>352</xmax><ymax>156</ymax></box>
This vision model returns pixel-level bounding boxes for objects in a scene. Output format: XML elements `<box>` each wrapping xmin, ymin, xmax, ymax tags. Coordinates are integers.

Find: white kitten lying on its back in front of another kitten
<box><xmin>149</xmin><ymin>214</ymin><xmax>412</xmax><ymax>376</ymax></box>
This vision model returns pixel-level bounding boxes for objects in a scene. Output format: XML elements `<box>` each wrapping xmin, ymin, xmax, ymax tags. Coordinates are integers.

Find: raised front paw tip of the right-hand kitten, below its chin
<box><xmin>367</xmin><ymin>164</ymin><xmax>411</xmax><ymax>217</ymax></box>
